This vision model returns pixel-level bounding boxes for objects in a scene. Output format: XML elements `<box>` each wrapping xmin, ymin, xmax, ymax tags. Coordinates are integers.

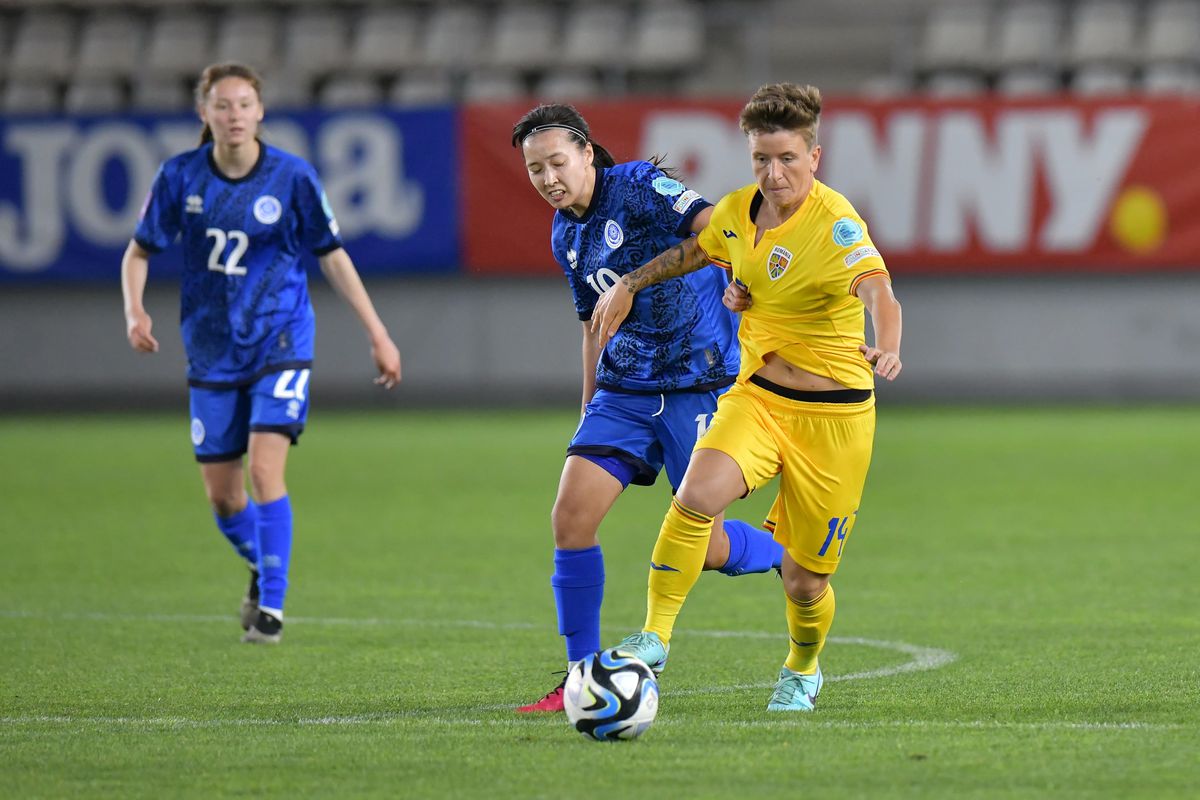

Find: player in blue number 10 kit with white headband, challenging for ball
<box><xmin>512</xmin><ymin>104</ymin><xmax>782</xmax><ymax>712</ymax></box>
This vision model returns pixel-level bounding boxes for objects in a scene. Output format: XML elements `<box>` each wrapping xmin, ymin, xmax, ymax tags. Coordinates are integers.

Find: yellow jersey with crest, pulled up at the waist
<box><xmin>698</xmin><ymin>181</ymin><xmax>888</xmax><ymax>389</ymax></box>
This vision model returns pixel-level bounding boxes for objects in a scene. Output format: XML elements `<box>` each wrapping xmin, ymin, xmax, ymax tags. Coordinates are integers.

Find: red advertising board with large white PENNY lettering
<box><xmin>461</xmin><ymin>97</ymin><xmax>1200</xmax><ymax>275</ymax></box>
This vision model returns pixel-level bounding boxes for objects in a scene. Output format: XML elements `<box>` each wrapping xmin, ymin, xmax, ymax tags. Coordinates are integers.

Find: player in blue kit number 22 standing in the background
<box><xmin>121</xmin><ymin>64</ymin><xmax>400</xmax><ymax>644</ymax></box>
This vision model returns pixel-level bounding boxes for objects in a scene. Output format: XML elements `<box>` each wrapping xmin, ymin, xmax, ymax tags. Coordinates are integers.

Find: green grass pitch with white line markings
<box><xmin>0</xmin><ymin>405</ymin><xmax>1200</xmax><ymax>799</ymax></box>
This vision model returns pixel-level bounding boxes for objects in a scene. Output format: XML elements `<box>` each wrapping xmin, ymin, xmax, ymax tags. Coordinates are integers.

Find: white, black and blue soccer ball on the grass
<box><xmin>563</xmin><ymin>648</ymin><xmax>659</xmax><ymax>741</ymax></box>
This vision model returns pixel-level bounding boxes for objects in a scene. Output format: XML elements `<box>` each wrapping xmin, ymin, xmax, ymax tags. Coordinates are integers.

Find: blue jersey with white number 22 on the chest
<box><xmin>133</xmin><ymin>144</ymin><xmax>342</xmax><ymax>389</ymax></box>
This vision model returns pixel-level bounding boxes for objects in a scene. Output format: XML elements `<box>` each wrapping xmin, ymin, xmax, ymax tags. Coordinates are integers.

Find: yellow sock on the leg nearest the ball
<box><xmin>642</xmin><ymin>498</ymin><xmax>713</xmax><ymax>644</ymax></box>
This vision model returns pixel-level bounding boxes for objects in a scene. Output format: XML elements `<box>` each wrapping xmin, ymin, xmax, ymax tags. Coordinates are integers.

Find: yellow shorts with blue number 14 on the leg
<box><xmin>696</xmin><ymin>383</ymin><xmax>875</xmax><ymax>573</ymax></box>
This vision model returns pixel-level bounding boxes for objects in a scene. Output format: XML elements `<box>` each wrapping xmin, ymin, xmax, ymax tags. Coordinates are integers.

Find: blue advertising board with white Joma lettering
<box><xmin>0</xmin><ymin>107</ymin><xmax>461</xmax><ymax>282</ymax></box>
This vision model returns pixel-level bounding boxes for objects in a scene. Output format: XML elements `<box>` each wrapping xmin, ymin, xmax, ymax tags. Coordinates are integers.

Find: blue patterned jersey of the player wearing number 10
<box><xmin>551</xmin><ymin>161</ymin><xmax>738</xmax><ymax>395</ymax></box>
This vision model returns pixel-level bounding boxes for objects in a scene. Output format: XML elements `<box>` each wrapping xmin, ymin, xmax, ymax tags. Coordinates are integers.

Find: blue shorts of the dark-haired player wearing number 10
<box><xmin>566</xmin><ymin>386</ymin><xmax>728</xmax><ymax>489</ymax></box>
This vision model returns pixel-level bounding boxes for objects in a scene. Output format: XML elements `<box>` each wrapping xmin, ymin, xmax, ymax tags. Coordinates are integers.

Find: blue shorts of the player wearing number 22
<box><xmin>188</xmin><ymin>369</ymin><xmax>310</xmax><ymax>464</ymax></box>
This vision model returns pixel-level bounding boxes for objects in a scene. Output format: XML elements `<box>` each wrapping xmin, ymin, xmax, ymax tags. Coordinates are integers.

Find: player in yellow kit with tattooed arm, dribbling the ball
<box><xmin>593</xmin><ymin>83</ymin><xmax>901</xmax><ymax>711</ymax></box>
